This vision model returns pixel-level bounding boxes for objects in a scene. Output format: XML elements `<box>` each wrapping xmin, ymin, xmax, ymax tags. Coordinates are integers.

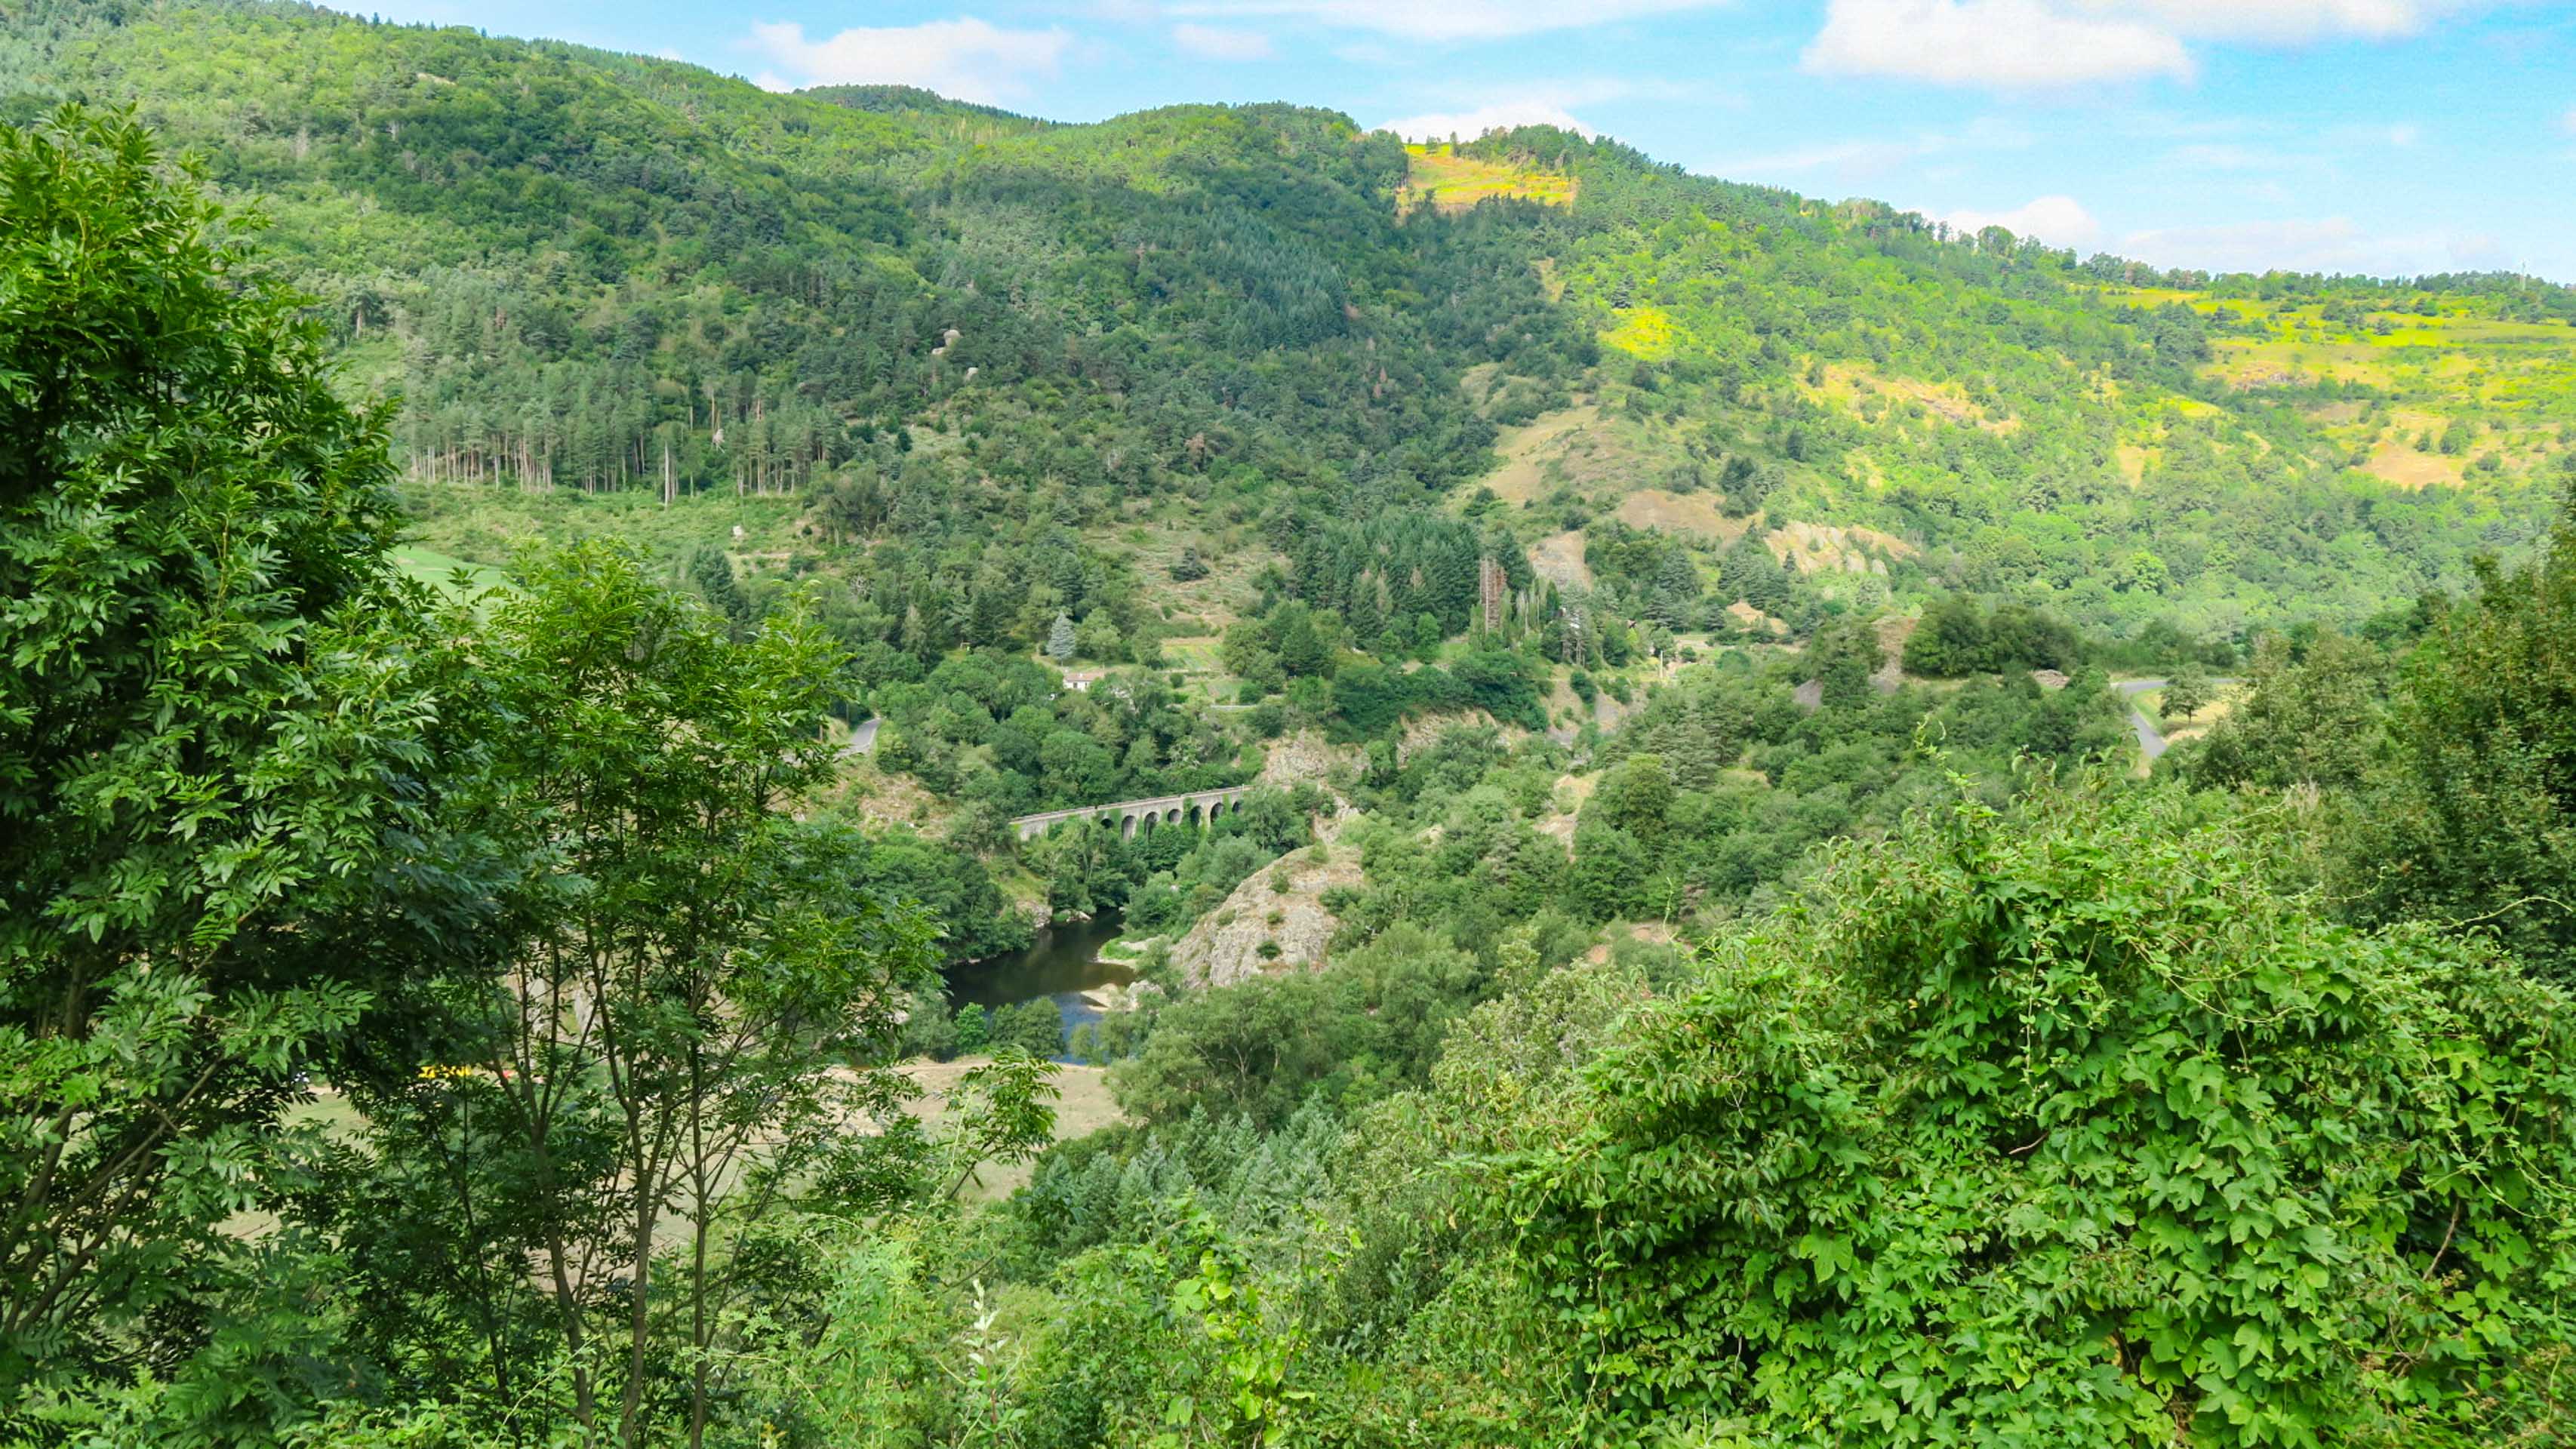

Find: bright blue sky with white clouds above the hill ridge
<box><xmin>352</xmin><ymin>0</ymin><xmax>2576</xmax><ymax>283</ymax></box>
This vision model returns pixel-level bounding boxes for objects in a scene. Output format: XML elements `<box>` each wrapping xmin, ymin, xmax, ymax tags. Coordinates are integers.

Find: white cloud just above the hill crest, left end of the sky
<box><xmin>749</xmin><ymin>15</ymin><xmax>1074</xmax><ymax>103</ymax></box>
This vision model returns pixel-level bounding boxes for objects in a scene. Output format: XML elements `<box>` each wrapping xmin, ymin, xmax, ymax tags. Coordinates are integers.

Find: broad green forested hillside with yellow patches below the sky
<box><xmin>0</xmin><ymin>2</ymin><xmax>2576</xmax><ymax>651</ymax></box>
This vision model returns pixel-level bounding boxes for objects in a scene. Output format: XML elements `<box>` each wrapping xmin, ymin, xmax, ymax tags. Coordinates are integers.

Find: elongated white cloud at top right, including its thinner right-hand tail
<box><xmin>1806</xmin><ymin>0</ymin><xmax>2481</xmax><ymax>90</ymax></box>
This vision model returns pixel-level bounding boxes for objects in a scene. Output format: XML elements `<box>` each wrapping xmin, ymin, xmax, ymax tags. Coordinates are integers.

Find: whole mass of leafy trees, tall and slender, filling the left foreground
<box><xmin>0</xmin><ymin>111</ymin><xmax>1046</xmax><ymax>1444</ymax></box>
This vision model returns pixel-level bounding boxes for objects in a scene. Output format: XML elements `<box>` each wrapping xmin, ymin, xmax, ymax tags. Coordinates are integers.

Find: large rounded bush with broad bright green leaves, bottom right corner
<box><xmin>1448</xmin><ymin>783</ymin><xmax>2576</xmax><ymax>1447</ymax></box>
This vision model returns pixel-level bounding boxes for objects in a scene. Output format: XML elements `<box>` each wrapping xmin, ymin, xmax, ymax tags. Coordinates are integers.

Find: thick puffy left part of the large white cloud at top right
<box><xmin>1806</xmin><ymin>0</ymin><xmax>2192</xmax><ymax>90</ymax></box>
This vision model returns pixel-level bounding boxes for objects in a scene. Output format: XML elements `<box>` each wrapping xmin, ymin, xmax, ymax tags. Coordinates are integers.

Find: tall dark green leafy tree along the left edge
<box><xmin>0</xmin><ymin>111</ymin><xmax>432</xmax><ymax>1416</ymax></box>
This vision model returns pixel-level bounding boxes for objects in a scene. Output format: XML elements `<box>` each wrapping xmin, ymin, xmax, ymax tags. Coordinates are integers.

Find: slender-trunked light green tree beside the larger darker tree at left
<box><xmin>337</xmin><ymin>543</ymin><xmax>933</xmax><ymax>1447</ymax></box>
